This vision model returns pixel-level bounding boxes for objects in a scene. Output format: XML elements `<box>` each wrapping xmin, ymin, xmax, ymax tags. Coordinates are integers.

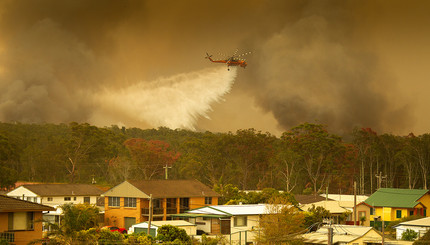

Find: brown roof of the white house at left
<box><xmin>22</xmin><ymin>184</ymin><xmax>103</xmax><ymax>196</ymax></box>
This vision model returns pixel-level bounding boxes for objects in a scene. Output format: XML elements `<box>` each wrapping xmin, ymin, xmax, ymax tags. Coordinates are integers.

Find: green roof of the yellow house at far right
<box><xmin>364</xmin><ymin>188</ymin><xmax>428</xmax><ymax>208</ymax></box>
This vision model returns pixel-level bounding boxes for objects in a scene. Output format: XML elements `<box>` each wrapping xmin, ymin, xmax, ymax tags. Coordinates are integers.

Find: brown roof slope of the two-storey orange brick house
<box><xmin>128</xmin><ymin>180</ymin><xmax>220</xmax><ymax>198</ymax></box>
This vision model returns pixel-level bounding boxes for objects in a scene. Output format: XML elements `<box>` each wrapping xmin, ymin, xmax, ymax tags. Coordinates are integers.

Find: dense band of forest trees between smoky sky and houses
<box><xmin>0</xmin><ymin>123</ymin><xmax>430</xmax><ymax>194</ymax></box>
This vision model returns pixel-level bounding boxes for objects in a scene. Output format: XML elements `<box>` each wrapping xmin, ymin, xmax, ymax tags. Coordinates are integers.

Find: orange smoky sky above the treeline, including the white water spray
<box><xmin>0</xmin><ymin>0</ymin><xmax>430</xmax><ymax>135</ymax></box>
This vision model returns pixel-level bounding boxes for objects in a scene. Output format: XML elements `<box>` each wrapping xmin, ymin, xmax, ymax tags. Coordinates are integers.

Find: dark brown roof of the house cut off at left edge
<box><xmin>0</xmin><ymin>195</ymin><xmax>55</xmax><ymax>212</ymax></box>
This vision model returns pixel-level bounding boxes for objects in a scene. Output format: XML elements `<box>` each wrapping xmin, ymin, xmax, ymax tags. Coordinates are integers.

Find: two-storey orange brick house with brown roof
<box><xmin>102</xmin><ymin>180</ymin><xmax>220</xmax><ymax>229</ymax></box>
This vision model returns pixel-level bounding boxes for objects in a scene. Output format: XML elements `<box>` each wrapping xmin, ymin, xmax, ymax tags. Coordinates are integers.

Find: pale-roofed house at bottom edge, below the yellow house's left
<box><xmin>302</xmin><ymin>225</ymin><xmax>404</xmax><ymax>245</ymax></box>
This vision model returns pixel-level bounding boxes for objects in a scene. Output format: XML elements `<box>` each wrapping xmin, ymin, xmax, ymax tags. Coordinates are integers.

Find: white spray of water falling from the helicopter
<box><xmin>93</xmin><ymin>66</ymin><xmax>237</xmax><ymax>130</ymax></box>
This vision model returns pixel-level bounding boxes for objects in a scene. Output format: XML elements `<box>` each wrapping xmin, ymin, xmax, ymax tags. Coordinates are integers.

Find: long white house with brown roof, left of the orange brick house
<box><xmin>7</xmin><ymin>184</ymin><xmax>103</xmax><ymax>207</ymax></box>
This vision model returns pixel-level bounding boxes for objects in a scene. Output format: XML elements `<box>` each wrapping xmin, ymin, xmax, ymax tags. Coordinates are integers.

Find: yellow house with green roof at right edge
<box><xmin>357</xmin><ymin>188</ymin><xmax>430</xmax><ymax>227</ymax></box>
